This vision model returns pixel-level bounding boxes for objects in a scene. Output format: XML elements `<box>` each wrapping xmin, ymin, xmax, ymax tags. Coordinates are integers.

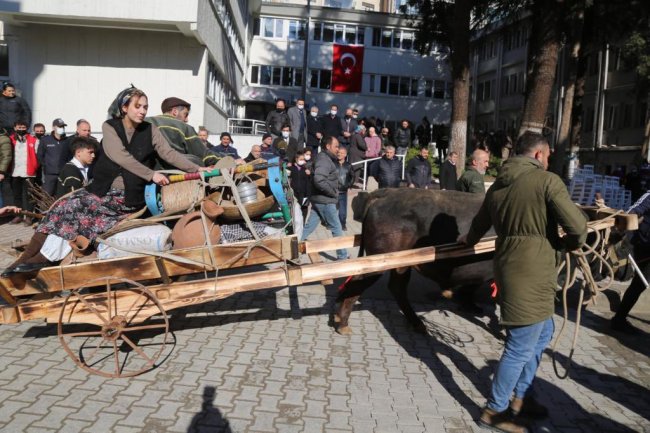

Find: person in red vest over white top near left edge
<box><xmin>9</xmin><ymin>120</ymin><xmax>39</xmax><ymax>225</ymax></box>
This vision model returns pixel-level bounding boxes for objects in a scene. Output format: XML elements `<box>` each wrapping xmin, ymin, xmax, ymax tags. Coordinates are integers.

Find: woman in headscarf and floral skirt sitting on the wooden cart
<box><xmin>3</xmin><ymin>86</ymin><xmax>205</xmax><ymax>276</ymax></box>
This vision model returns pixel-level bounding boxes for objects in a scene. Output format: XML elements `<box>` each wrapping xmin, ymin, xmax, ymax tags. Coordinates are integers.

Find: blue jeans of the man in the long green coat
<box><xmin>487</xmin><ymin>318</ymin><xmax>555</xmax><ymax>412</ymax></box>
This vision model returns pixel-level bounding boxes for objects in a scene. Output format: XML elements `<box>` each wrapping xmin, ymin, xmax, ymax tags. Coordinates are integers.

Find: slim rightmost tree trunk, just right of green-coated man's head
<box><xmin>551</xmin><ymin>1</ymin><xmax>585</xmax><ymax>176</ymax></box>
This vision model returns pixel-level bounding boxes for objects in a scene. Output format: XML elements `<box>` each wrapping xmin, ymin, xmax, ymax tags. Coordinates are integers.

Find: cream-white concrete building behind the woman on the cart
<box><xmin>0</xmin><ymin>0</ymin><xmax>260</xmax><ymax>131</ymax></box>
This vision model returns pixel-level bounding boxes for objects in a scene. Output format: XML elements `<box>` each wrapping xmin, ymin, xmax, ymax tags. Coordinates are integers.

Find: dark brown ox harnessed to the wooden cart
<box><xmin>334</xmin><ymin>188</ymin><xmax>493</xmax><ymax>334</ymax></box>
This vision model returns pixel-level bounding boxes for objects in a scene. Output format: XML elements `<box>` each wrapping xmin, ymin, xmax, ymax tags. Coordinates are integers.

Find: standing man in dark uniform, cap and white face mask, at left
<box><xmin>36</xmin><ymin>118</ymin><xmax>69</xmax><ymax>196</ymax></box>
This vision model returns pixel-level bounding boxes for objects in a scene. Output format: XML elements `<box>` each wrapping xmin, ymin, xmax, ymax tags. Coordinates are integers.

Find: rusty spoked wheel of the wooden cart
<box><xmin>58</xmin><ymin>277</ymin><xmax>169</xmax><ymax>377</ymax></box>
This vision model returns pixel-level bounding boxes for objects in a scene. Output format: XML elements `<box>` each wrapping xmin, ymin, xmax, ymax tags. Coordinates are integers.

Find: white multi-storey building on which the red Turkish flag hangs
<box><xmin>241</xmin><ymin>3</ymin><xmax>452</xmax><ymax>130</ymax></box>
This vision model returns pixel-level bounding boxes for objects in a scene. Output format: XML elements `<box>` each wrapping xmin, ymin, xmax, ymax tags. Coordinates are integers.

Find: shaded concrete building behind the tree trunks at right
<box><xmin>469</xmin><ymin>17</ymin><xmax>647</xmax><ymax>174</ymax></box>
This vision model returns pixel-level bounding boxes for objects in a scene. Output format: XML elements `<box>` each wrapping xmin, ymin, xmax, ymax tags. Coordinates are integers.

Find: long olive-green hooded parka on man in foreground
<box><xmin>467</xmin><ymin>156</ymin><xmax>587</xmax><ymax>326</ymax></box>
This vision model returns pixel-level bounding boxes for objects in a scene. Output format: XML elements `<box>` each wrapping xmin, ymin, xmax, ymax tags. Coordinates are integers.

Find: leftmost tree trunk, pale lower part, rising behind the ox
<box><xmin>450</xmin><ymin>0</ymin><xmax>472</xmax><ymax>176</ymax></box>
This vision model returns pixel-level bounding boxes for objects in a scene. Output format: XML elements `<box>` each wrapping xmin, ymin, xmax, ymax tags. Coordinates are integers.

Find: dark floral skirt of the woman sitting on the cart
<box><xmin>36</xmin><ymin>189</ymin><xmax>135</xmax><ymax>241</ymax></box>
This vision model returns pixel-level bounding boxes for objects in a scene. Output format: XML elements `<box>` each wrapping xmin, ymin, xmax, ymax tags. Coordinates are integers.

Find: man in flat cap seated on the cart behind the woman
<box><xmin>145</xmin><ymin>97</ymin><xmax>217</xmax><ymax>169</ymax></box>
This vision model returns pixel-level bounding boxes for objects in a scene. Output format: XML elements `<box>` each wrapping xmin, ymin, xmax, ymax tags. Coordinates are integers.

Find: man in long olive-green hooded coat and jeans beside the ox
<box><xmin>459</xmin><ymin>132</ymin><xmax>587</xmax><ymax>432</ymax></box>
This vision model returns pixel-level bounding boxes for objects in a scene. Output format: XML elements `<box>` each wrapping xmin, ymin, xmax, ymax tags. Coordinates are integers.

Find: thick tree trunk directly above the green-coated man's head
<box><xmin>519</xmin><ymin>0</ymin><xmax>562</xmax><ymax>135</ymax></box>
